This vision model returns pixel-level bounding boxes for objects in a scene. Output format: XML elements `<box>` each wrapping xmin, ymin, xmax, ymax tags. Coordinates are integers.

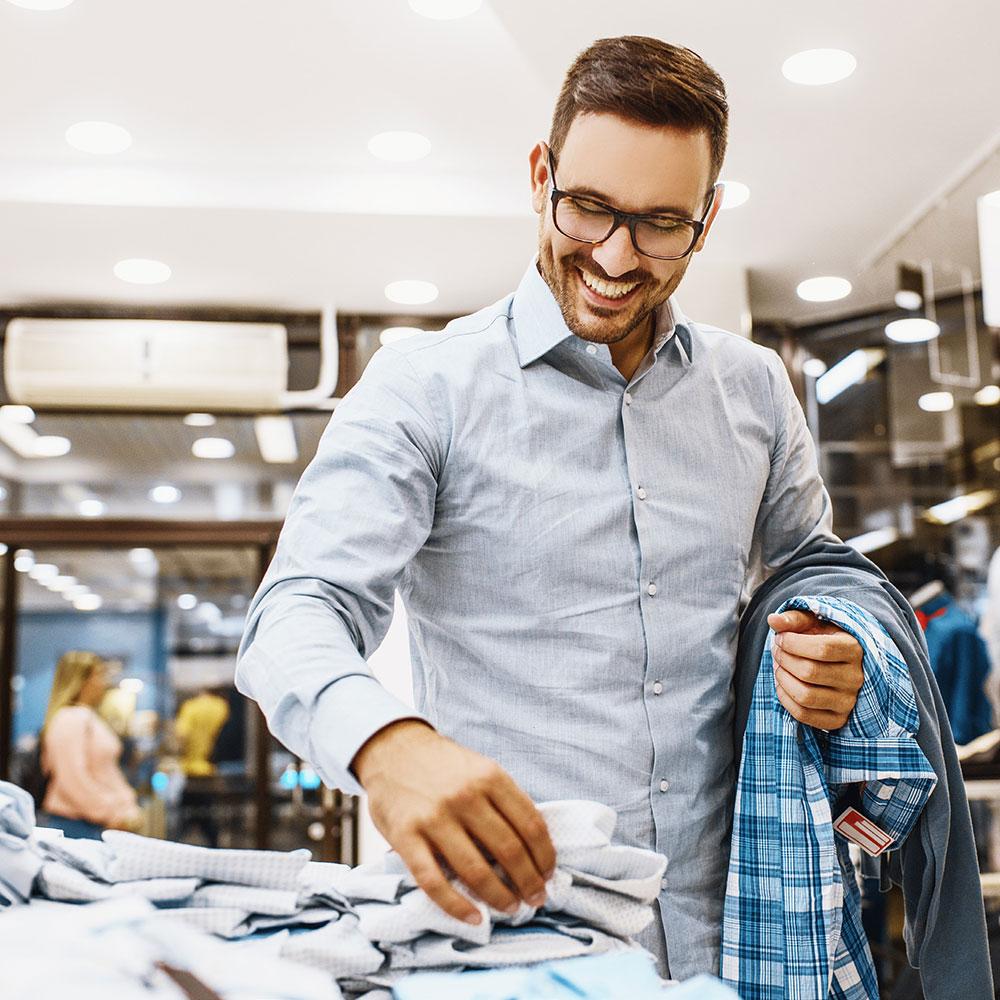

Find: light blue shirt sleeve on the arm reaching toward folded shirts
<box><xmin>236</xmin><ymin>348</ymin><xmax>445</xmax><ymax>794</ymax></box>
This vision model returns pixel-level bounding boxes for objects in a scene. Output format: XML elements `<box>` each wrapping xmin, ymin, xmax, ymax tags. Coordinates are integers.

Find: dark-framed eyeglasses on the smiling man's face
<box><xmin>549</xmin><ymin>149</ymin><xmax>718</xmax><ymax>260</ymax></box>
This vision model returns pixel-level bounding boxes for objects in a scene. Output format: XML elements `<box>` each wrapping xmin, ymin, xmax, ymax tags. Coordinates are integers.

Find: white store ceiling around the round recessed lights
<box><xmin>0</xmin><ymin>0</ymin><xmax>1000</xmax><ymax>322</ymax></box>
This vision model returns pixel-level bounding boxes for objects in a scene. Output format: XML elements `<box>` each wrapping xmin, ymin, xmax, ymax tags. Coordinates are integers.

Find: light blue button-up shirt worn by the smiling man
<box><xmin>237</xmin><ymin>263</ymin><xmax>834</xmax><ymax>978</ymax></box>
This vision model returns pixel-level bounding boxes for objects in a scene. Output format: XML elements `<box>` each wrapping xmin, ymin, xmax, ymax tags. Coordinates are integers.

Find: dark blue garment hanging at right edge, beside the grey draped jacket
<box><xmin>916</xmin><ymin>593</ymin><xmax>993</xmax><ymax>744</ymax></box>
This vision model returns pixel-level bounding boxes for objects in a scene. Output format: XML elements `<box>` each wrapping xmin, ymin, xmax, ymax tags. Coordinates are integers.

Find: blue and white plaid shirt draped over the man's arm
<box><xmin>722</xmin><ymin>597</ymin><xmax>937</xmax><ymax>1000</ymax></box>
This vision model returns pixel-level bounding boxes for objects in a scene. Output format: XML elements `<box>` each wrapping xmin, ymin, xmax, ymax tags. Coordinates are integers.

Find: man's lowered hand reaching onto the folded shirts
<box><xmin>352</xmin><ymin>719</ymin><xmax>556</xmax><ymax>924</ymax></box>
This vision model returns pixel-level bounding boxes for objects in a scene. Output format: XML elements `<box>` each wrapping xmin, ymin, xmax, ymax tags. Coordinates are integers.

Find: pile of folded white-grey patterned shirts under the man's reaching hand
<box><xmin>0</xmin><ymin>785</ymin><xmax>666</xmax><ymax>994</ymax></box>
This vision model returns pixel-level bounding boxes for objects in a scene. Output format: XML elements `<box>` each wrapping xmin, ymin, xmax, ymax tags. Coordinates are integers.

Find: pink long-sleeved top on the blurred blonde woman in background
<box><xmin>42</xmin><ymin>705</ymin><xmax>136</xmax><ymax>826</ymax></box>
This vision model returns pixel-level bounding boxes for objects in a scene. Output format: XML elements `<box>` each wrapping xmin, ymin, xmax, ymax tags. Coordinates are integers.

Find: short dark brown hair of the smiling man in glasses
<box><xmin>549</xmin><ymin>35</ymin><xmax>729</xmax><ymax>182</ymax></box>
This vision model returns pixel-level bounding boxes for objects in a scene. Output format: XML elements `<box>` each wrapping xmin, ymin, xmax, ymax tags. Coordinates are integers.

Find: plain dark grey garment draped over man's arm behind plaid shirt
<box><xmin>734</xmin><ymin>541</ymin><xmax>993</xmax><ymax>1000</ymax></box>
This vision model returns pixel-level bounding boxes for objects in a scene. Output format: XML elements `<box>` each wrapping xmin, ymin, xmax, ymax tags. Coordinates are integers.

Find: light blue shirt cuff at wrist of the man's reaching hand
<box><xmin>309</xmin><ymin>674</ymin><xmax>430</xmax><ymax>795</ymax></box>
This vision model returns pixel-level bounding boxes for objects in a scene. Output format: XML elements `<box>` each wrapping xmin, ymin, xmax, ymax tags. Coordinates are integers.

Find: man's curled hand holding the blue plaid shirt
<box><xmin>767</xmin><ymin>611</ymin><xmax>865</xmax><ymax>730</ymax></box>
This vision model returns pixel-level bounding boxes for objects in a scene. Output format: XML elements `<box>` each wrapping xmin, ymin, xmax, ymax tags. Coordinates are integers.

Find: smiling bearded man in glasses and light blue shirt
<box><xmin>238</xmin><ymin>37</ymin><xmax>862</xmax><ymax>978</ymax></box>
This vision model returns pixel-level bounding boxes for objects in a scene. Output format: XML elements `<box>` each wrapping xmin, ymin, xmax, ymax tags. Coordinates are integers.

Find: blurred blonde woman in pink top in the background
<box><xmin>37</xmin><ymin>651</ymin><xmax>142</xmax><ymax>839</ymax></box>
